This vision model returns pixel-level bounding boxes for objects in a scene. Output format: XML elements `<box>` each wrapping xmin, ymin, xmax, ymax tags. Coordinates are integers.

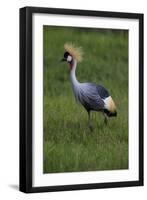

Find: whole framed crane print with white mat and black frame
<box><xmin>20</xmin><ymin>7</ymin><xmax>143</xmax><ymax>193</ymax></box>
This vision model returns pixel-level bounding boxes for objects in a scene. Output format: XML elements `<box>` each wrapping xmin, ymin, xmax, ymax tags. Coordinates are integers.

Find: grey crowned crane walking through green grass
<box><xmin>62</xmin><ymin>43</ymin><xmax>117</xmax><ymax>131</ymax></box>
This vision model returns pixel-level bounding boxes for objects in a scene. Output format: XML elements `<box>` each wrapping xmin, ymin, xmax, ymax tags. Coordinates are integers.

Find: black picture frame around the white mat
<box><xmin>20</xmin><ymin>7</ymin><xmax>143</xmax><ymax>193</ymax></box>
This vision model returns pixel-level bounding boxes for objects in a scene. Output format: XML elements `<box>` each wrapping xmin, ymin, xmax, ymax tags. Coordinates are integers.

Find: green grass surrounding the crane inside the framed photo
<box><xmin>43</xmin><ymin>26</ymin><xmax>128</xmax><ymax>173</ymax></box>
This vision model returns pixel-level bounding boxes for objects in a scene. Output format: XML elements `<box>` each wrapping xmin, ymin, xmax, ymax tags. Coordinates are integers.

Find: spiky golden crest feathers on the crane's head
<box><xmin>64</xmin><ymin>43</ymin><xmax>83</xmax><ymax>62</ymax></box>
